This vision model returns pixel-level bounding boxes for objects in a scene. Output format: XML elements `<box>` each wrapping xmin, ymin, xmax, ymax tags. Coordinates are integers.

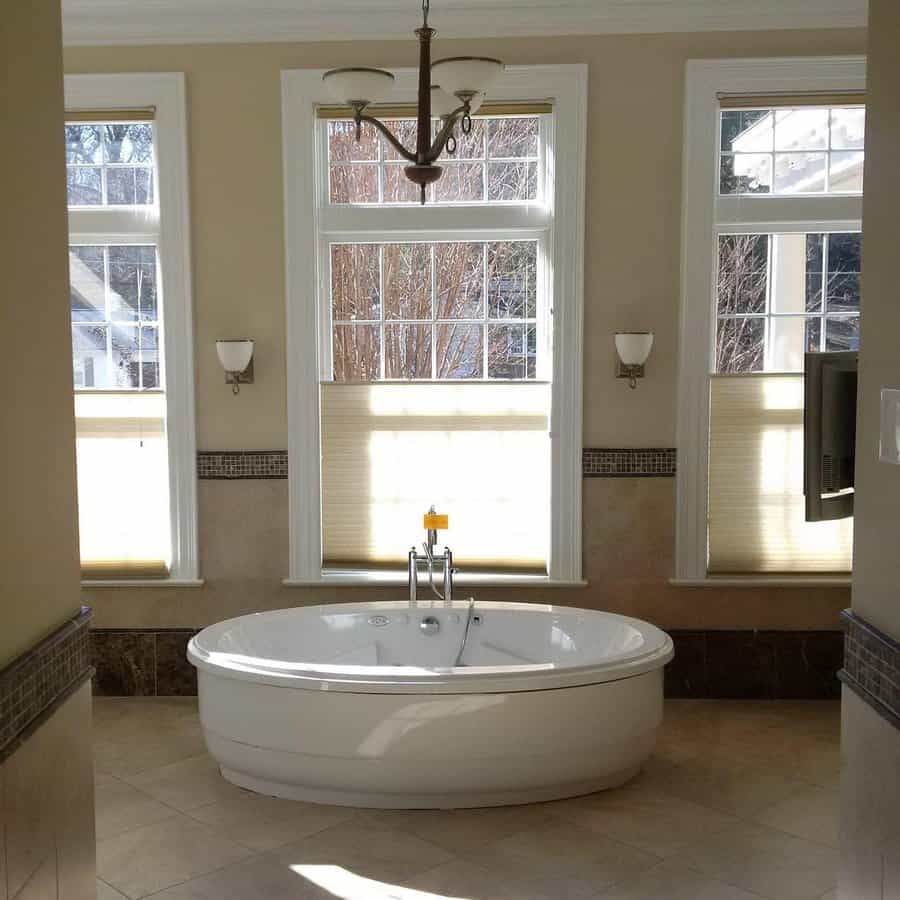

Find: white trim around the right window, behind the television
<box><xmin>672</xmin><ymin>56</ymin><xmax>866</xmax><ymax>587</ymax></box>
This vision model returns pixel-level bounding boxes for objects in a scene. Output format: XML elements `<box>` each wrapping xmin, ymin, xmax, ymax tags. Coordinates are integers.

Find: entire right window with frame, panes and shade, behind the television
<box><xmin>676</xmin><ymin>59</ymin><xmax>865</xmax><ymax>583</ymax></box>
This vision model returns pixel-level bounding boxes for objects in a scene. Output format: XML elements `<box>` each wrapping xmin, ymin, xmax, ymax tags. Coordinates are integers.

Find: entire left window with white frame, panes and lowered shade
<box><xmin>65</xmin><ymin>75</ymin><xmax>197</xmax><ymax>584</ymax></box>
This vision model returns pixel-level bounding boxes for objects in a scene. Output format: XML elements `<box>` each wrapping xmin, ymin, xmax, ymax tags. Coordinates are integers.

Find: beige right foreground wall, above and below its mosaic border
<box><xmin>838</xmin><ymin>0</ymin><xmax>900</xmax><ymax>900</ymax></box>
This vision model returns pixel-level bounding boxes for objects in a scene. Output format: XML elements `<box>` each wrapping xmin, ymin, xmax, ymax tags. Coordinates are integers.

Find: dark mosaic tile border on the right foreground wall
<box><xmin>839</xmin><ymin>609</ymin><xmax>900</xmax><ymax>729</ymax></box>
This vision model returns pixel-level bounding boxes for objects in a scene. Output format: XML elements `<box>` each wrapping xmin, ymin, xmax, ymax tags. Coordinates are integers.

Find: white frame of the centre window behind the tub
<box><xmin>281</xmin><ymin>64</ymin><xmax>587</xmax><ymax>585</ymax></box>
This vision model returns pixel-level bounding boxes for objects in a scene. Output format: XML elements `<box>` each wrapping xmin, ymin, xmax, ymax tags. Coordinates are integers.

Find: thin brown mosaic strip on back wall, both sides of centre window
<box><xmin>197</xmin><ymin>447</ymin><xmax>676</xmax><ymax>481</ymax></box>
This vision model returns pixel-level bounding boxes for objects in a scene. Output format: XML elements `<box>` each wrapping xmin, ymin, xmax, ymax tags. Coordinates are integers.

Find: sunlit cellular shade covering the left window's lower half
<box><xmin>75</xmin><ymin>391</ymin><xmax>171</xmax><ymax>578</ymax></box>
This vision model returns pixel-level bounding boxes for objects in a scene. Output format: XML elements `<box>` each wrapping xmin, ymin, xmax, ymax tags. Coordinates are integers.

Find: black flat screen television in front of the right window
<box><xmin>803</xmin><ymin>351</ymin><xmax>859</xmax><ymax>522</ymax></box>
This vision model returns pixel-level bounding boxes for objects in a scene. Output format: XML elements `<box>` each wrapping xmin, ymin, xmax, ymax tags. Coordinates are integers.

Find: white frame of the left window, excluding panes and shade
<box><xmin>60</xmin><ymin>72</ymin><xmax>203</xmax><ymax>587</ymax></box>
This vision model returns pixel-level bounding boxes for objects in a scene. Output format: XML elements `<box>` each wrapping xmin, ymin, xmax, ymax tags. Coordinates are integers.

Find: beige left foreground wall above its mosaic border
<box><xmin>0</xmin><ymin>0</ymin><xmax>79</xmax><ymax>665</ymax></box>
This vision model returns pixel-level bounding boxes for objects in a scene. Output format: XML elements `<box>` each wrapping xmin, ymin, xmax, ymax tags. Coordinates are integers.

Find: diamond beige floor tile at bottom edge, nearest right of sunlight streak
<box><xmin>470</xmin><ymin>821</ymin><xmax>659</xmax><ymax>900</ymax></box>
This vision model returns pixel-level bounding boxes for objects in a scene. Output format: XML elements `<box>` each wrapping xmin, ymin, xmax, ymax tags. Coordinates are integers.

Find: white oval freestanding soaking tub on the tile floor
<box><xmin>188</xmin><ymin>602</ymin><xmax>672</xmax><ymax>809</ymax></box>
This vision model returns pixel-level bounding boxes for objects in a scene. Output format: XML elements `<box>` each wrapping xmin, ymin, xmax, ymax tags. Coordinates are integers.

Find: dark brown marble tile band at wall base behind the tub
<box><xmin>91</xmin><ymin>628</ymin><xmax>843</xmax><ymax>700</ymax></box>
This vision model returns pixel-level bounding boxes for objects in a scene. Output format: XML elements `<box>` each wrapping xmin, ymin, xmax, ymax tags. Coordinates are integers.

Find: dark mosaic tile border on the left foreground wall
<box><xmin>0</xmin><ymin>606</ymin><xmax>93</xmax><ymax>761</ymax></box>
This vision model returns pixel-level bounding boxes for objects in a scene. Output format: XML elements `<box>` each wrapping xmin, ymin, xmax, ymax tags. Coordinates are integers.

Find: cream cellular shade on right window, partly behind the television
<box><xmin>708</xmin><ymin>375</ymin><xmax>853</xmax><ymax>575</ymax></box>
